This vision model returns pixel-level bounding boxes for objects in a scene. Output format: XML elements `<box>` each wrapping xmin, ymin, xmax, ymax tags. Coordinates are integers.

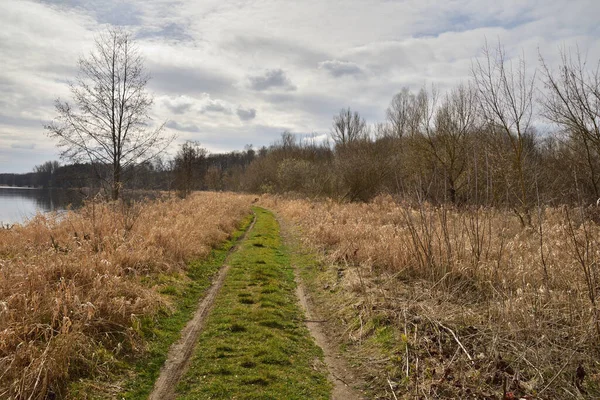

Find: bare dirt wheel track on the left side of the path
<box><xmin>148</xmin><ymin>216</ymin><xmax>256</xmax><ymax>400</ymax></box>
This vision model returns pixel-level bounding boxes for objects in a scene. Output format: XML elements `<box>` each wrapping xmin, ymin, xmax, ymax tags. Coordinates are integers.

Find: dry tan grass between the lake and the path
<box><xmin>0</xmin><ymin>193</ymin><xmax>252</xmax><ymax>399</ymax></box>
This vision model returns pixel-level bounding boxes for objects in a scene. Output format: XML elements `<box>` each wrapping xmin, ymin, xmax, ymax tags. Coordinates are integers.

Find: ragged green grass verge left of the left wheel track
<box><xmin>69</xmin><ymin>215</ymin><xmax>252</xmax><ymax>400</ymax></box>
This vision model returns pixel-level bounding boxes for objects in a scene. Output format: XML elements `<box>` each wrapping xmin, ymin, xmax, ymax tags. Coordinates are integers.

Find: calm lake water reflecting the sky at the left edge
<box><xmin>0</xmin><ymin>186</ymin><xmax>82</xmax><ymax>224</ymax></box>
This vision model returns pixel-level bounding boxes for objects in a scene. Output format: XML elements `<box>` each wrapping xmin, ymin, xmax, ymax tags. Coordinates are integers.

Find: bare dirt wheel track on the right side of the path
<box><xmin>296</xmin><ymin>274</ymin><xmax>365</xmax><ymax>400</ymax></box>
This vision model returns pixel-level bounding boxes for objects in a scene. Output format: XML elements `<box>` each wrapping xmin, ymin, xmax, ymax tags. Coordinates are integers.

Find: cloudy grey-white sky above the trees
<box><xmin>0</xmin><ymin>0</ymin><xmax>600</xmax><ymax>172</ymax></box>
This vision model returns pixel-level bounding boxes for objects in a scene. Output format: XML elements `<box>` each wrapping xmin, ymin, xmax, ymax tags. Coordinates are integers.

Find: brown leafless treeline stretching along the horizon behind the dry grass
<box><xmin>8</xmin><ymin>45</ymin><xmax>600</xmax><ymax>219</ymax></box>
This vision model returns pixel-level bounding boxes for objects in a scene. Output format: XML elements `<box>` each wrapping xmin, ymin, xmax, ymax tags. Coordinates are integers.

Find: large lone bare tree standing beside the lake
<box><xmin>45</xmin><ymin>28</ymin><xmax>173</xmax><ymax>200</ymax></box>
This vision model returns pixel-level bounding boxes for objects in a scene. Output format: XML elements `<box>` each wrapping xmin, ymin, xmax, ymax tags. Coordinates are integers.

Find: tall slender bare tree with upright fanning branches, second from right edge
<box><xmin>472</xmin><ymin>43</ymin><xmax>535</xmax><ymax>224</ymax></box>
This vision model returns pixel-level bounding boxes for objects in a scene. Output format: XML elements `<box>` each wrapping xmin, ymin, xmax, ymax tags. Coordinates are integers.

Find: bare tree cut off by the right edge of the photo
<box><xmin>540</xmin><ymin>50</ymin><xmax>600</xmax><ymax>198</ymax></box>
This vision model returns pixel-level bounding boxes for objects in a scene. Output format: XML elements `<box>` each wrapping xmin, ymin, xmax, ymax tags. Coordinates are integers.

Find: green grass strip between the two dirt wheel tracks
<box><xmin>177</xmin><ymin>208</ymin><xmax>331</xmax><ymax>399</ymax></box>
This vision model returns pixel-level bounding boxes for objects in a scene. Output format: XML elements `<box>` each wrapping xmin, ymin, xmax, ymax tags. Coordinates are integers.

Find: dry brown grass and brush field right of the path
<box><xmin>262</xmin><ymin>197</ymin><xmax>600</xmax><ymax>399</ymax></box>
